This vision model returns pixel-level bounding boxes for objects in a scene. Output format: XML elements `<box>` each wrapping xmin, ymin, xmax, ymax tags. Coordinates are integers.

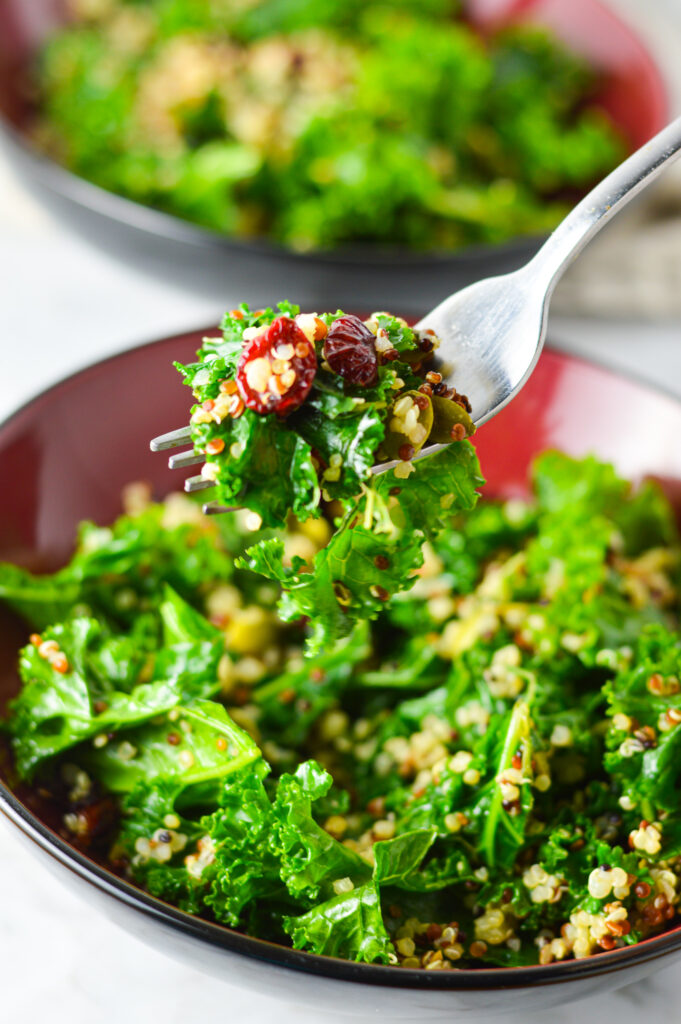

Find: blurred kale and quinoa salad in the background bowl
<box><xmin>34</xmin><ymin>0</ymin><xmax>626</xmax><ymax>251</ymax></box>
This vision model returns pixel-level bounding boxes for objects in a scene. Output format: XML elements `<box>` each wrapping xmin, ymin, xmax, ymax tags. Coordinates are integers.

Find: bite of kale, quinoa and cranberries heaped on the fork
<box><xmin>175</xmin><ymin>302</ymin><xmax>475</xmax><ymax>526</ymax></box>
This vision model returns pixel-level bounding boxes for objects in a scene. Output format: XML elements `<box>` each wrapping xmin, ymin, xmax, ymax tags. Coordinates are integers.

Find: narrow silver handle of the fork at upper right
<box><xmin>526</xmin><ymin>117</ymin><xmax>681</xmax><ymax>295</ymax></box>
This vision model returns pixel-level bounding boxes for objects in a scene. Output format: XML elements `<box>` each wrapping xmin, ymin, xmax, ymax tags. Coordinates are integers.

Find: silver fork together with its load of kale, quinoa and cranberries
<box><xmin>151</xmin><ymin>118</ymin><xmax>681</xmax><ymax>524</ymax></box>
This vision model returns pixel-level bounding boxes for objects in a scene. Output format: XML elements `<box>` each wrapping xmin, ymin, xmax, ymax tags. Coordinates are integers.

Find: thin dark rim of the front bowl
<box><xmin>0</xmin><ymin>326</ymin><xmax>681</xmax><ymax>991</ymax></box>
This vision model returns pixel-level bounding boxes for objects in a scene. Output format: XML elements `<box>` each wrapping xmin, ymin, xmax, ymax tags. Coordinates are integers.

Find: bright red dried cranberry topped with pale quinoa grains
<box><xmin>237</xmin><ymin>316</ymin><xmax>316</xmax><ymax>416</ymax></box>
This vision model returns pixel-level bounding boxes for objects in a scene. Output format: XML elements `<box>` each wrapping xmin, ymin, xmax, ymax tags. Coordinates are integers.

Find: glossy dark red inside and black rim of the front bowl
<box><xmin>0</xmin><ymin>329</ymin><xmax>681</xmax><ymax>988</ymax></box>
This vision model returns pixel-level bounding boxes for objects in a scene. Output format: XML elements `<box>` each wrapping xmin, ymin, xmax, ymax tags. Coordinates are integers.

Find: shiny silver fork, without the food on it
<box><xmin>151</xmin><ymin>118</ymin><xmax>681</xmax><ymax>513</ymax></box>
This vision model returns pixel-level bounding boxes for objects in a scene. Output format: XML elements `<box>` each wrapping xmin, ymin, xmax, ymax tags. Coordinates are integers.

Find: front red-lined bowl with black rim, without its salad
<box><xmin>0</xmin><ymin>331</ymin><xmax>681</xmax><ymax>1021</ymax></box>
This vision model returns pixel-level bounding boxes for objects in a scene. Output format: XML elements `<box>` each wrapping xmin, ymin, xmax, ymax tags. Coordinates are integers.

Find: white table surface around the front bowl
<box><xmin>0</xmin><ymin>25</ymin><xmax>681</xmax><ymax>1024</ymax></box>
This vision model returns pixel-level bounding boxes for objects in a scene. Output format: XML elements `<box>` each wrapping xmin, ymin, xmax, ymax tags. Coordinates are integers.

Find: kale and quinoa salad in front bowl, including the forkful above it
<box><xmin>0</xmin><ymin>304</ymin><xmax>681</xmax><ymax>970</ymax></box>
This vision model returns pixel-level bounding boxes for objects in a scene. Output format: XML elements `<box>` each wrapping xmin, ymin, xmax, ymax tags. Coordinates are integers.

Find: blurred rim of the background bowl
<box><xmin>0</xmin><ymin>0</ymin><xmax>669</xmax><ymax>271</ymax></box>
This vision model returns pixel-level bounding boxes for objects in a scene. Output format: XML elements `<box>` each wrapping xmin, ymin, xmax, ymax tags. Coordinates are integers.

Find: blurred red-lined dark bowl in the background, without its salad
<box><xmin>0</xmin><ymin>0</ymin><xmax>667</xmax><ymax>314</ymax></box>
